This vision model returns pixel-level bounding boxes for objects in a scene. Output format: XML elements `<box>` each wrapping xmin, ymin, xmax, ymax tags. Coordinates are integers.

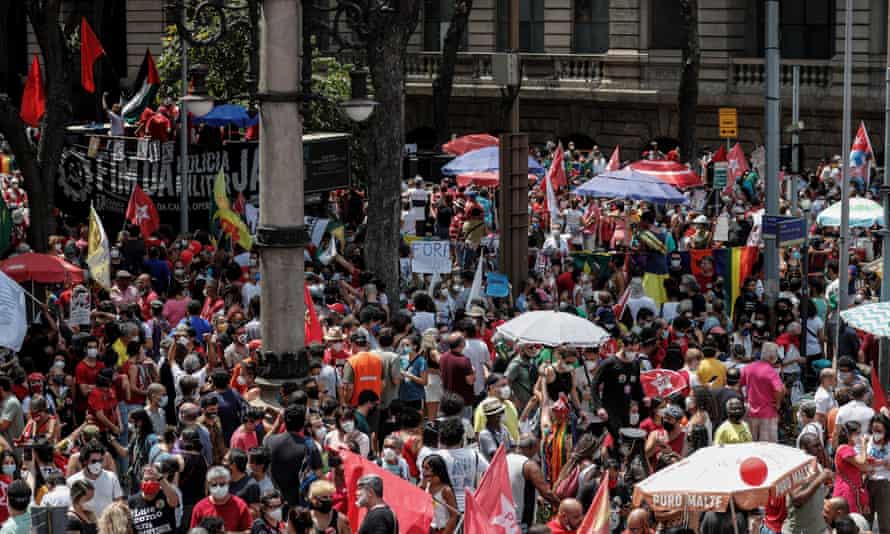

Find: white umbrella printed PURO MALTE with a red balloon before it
<box><xmin>633</xmin><ymin>442</ymin><xmax>819</xmax><ymax>512</ymax></box>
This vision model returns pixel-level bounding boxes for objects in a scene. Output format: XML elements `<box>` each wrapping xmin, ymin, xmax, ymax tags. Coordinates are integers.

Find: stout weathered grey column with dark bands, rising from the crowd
<box><xmin>257</xmin><ymin>0</ymin><xmax>306</xmax><ymax>354</ymax></box>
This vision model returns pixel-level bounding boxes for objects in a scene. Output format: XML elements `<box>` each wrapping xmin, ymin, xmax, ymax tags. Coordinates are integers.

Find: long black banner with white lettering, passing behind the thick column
<box><xmin>56</xmin><ymin>134</ymin><xmax>350</xmax><ymax>235</ymax></box>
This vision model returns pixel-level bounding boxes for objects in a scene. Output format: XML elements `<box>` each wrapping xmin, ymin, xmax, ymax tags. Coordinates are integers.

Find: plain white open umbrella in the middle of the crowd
<box><xmin>497</xmin><ymin>311</ymin><xmax>610</xmax><ymax>347</ymax></box>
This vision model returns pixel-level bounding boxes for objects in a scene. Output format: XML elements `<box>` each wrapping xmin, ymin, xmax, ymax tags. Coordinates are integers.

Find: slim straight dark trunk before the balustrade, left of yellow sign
<box><xmin>678</xmin><ymin>0</ymin><xmax>701</xmax><ymax>165</ymax></box>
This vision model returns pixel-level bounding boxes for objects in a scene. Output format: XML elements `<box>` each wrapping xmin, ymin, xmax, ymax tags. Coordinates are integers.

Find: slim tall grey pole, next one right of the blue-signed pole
<box><xmin>834</xmin><ymin>0</ymin><xmax>852</xmax><ymax>361</ymax></box>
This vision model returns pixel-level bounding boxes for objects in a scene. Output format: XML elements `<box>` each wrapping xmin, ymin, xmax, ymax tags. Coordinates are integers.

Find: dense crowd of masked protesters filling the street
<box><xmin>0</xmin><ymin>137</ymin><xmax>890</xmax><ymax>534</ymax></box>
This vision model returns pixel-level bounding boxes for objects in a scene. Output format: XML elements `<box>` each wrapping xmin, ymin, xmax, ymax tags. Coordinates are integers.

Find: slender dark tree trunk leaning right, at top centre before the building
<box><xmin>433</xmin><ymin>0</ymin><xmax>473</xmax><ymax>144</ymax></box>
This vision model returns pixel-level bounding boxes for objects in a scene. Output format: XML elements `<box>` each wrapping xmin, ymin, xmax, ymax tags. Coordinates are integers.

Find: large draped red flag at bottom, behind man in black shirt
<box><xmin>340</xmin><ymin>451</ymin><xmax>433</xmax><ymax>534</ymax></box>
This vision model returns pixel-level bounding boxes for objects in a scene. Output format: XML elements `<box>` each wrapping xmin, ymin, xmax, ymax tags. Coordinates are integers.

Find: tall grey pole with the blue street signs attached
<box><xmin>764</xmin><ymin>0</ymin><xmax>781</xmax><ymax>309</ymax></box>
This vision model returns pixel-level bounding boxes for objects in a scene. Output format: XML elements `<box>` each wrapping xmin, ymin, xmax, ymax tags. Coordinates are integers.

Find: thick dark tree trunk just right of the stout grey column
<box><xmin>365</xmin><ymin>0</ymin><xmax>420</xmax><ymax>309</ymax></box>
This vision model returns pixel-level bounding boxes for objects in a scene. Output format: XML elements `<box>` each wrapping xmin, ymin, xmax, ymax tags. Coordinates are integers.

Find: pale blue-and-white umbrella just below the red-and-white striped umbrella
<box><xmin>575</xmin><ymin>167</ymin><xmax>687</xmax><ymax>204</ymax></box>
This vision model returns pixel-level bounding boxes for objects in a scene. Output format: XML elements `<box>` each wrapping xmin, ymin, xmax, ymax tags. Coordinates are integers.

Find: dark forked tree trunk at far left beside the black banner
<box><xmin>0</xmin><ymin>0</ymin><xmax>72</xmax><ymax>252</ymax></box>
